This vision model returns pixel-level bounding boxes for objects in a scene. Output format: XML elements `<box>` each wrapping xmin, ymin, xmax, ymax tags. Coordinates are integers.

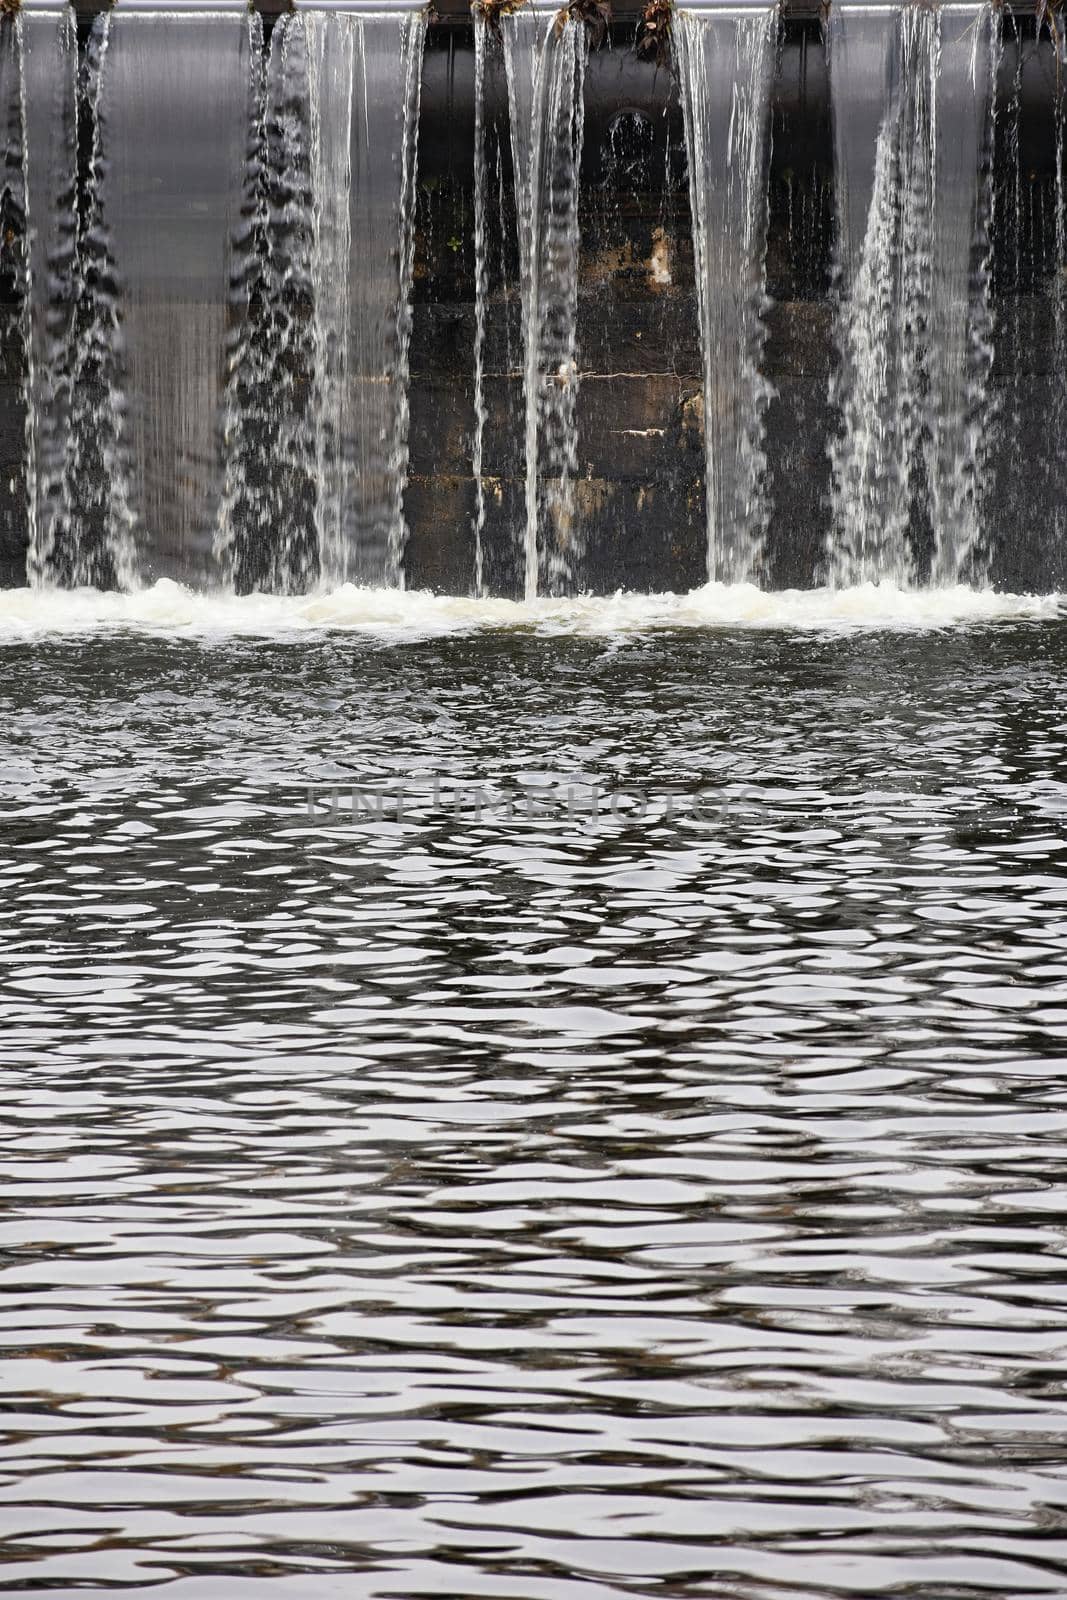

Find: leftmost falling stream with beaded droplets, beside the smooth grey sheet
<box><xmin>0</xmin><ymin>8</ymin><xmax>133</xmax><ymax>589</ymax></box>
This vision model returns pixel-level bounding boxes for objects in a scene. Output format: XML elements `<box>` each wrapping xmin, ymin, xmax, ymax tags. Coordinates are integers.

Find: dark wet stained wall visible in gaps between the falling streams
<box><xmin>0</xmin><ymin>18</ymin><xmax>1067</xmax><ymax>594</ymax></box>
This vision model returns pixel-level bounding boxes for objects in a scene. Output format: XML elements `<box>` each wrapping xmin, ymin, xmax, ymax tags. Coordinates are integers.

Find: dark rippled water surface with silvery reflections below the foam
<box><xmin>0</xmin><ymin>604</ymin><xmax>1067</xmax><ymax>1600</ymax></box>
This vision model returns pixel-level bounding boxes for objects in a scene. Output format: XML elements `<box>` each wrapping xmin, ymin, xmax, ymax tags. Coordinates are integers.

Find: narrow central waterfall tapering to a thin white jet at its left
<box><xmin>501</xmin><ymin>5</ymin><xmax>589</xmax><ymax>600</ymax></box>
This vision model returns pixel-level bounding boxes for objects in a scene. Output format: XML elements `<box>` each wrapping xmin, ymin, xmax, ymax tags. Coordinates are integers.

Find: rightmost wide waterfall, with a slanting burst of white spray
<box><xmin>829</xmin><ymin>3</ymin><xmax>1000</xmax><ymax>584</ymax></box>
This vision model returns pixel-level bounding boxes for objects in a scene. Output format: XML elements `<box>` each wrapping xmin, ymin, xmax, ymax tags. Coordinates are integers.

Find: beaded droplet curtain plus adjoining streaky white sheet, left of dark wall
<box><xmin>219</xmin><ymin>10</ymin><xmax>426</xmax><ymax>590</ymax></box>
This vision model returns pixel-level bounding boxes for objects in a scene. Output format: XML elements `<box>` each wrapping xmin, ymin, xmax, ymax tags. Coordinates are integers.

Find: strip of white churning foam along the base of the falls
<box><xmin>0</xmin><ymin>578</ymin><xmax>1067</xmax><ymax>643</ymax></box>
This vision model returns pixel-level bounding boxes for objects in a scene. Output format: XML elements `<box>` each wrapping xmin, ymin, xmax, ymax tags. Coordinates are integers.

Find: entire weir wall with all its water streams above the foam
<box><xmin>0</xmin><ymin>0</ymin><xmax>1067</xmax><ymax>598</ymax></box>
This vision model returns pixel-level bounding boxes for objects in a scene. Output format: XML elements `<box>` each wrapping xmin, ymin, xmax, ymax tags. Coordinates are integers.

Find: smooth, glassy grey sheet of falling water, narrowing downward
<box><xmin>92</xmin><ymin>6</ymin><xmax>261</xmax><ymax>587</ymax></box>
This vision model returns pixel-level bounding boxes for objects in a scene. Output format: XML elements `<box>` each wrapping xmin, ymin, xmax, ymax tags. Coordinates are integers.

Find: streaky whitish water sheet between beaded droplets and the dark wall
<box><xmin>302</xmin><ymin>11</ymin><xmax>426</xmax><ymax>587</ymax></box>
